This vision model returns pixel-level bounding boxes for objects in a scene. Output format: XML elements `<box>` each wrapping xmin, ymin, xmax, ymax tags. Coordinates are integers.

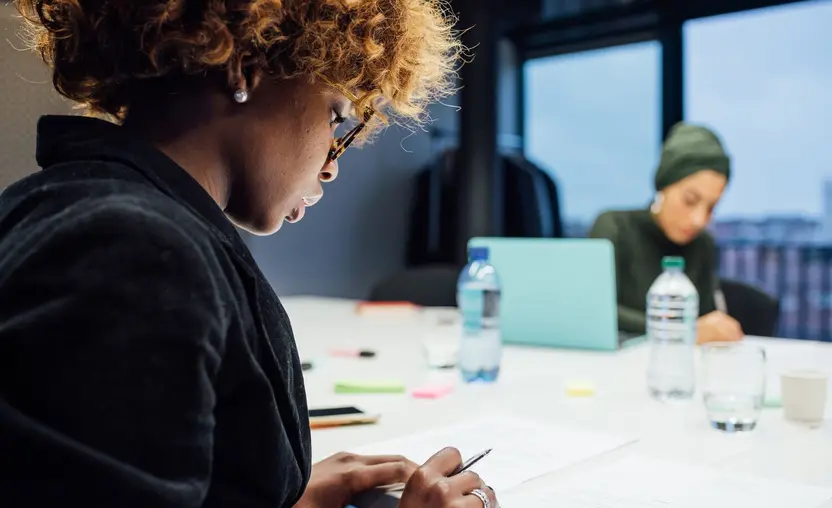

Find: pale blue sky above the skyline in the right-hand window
<box><xmin>684</xmin><ymin>1</ymin><xmax>832</xmax><ymax>228</ymax></box>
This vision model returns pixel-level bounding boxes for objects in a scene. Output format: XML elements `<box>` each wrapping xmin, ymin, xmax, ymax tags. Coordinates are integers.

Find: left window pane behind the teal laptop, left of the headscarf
<box><xmin>524</xmin><ymin>41</ymin><xmax>661</xmax><ymax>236</ymax></box>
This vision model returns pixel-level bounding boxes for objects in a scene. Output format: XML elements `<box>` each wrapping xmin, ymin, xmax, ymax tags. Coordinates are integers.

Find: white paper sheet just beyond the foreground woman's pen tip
<box><xmin>353</xmin><ymin>418</ymin><xmax>632</xmax><ymax>494</ymax></box>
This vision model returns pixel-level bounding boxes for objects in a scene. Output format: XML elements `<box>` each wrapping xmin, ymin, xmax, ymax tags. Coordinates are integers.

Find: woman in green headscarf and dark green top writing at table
<box><xmin>589</xmin><ymin>122</ymin><xmax>743</xmax><ymax>343</ymax></box>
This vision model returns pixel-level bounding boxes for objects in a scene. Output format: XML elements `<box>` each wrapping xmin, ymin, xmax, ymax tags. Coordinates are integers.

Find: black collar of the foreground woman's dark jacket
<box><xmin>36</xmin><ymin>116</ymin><xmax>248</xmax><ymax>250</ymax></box>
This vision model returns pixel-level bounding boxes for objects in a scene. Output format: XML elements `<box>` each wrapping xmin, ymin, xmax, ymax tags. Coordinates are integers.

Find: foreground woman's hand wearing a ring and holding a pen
<box><xmin>399</xmin><ymin>448</ymin><xmax>498</xmax><ymax>508</ymax></box>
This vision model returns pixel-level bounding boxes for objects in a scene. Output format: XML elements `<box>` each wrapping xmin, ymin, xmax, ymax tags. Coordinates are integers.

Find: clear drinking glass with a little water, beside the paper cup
<box><xmin>702</xmin><ymin>343</ymin><xmax>766</xmax><ymax>432</ymax></box>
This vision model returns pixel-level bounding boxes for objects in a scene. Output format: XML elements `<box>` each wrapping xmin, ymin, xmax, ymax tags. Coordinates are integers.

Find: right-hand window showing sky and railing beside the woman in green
<box><xmin>684</xmin><ymin>1</ymin><xmax>832</xmax><ymax>339</ymax></box>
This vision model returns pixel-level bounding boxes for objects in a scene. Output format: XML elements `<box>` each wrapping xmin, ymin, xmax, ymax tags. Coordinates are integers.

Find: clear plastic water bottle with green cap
<box><xmin>647</xmin><ymin>256</ymin><xmax>699</xmax><ymax>400</ymax></box>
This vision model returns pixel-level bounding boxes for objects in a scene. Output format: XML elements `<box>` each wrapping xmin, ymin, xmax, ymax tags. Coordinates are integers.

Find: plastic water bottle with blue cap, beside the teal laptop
<box><xmin>456</xmin><ymin>247</ymin><xmax>503</xmax><ymax>383</ymax></box>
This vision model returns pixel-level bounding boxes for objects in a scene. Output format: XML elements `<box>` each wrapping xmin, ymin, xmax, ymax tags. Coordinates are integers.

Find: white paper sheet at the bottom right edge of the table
<box><xmin>500</xmin><ymin>457</ymin><xmax>832</xmax><ymax>508</ymax></box>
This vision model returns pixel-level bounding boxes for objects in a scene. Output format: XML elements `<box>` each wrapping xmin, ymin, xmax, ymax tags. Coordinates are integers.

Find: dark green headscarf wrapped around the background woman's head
<box><xmin>655</xmin><ymin>122</ymin><xmax>731</xmax><ymax>191</ymax></box>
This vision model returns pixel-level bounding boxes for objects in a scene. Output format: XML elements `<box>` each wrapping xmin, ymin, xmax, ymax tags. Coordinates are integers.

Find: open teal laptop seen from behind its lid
<box><xmin>468</xmin><ymin>238</ymin><xmax>636</xmax><ymax>351</ymax></box>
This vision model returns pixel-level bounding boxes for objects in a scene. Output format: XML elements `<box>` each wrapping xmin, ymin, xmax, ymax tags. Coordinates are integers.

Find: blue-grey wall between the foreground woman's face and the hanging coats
<box><xmin>247</xmin><ymin>101</ymin><xmax>459</xmax><ymax>298</ymax></box>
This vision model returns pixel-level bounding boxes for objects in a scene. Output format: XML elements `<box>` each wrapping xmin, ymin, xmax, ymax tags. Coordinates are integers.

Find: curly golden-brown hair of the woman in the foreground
<box><xmin>13</xmin><ymin>0</ymin><xmax>463</xmax><ymax>135</ymax></box>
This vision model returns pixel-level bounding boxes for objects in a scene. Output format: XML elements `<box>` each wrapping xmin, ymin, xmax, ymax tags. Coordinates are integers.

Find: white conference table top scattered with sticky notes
<box><xmin>281</xmin><ymin>297</ymin><xmax>832</xmax><ymax>507</ymax></box>
